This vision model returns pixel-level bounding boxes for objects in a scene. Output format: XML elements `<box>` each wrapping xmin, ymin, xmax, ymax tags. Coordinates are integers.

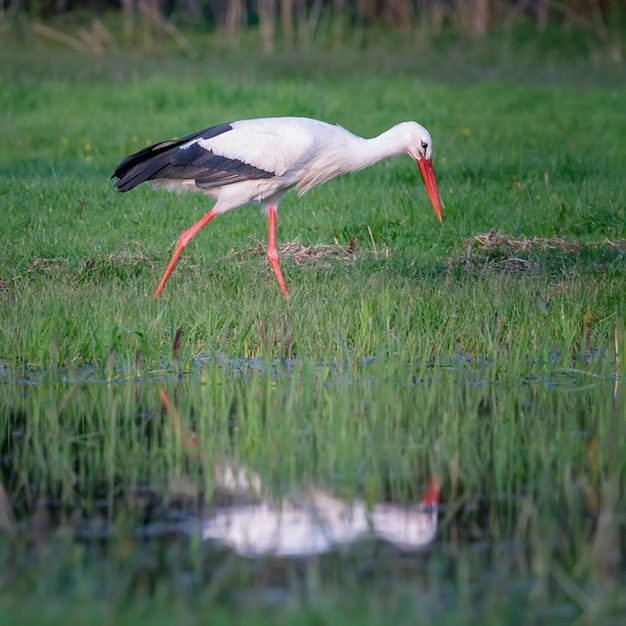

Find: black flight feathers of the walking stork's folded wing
<box><xmin>111</xmin><ymin>124</ymin><xmax>273</xmax><ymax>192</ymax></box>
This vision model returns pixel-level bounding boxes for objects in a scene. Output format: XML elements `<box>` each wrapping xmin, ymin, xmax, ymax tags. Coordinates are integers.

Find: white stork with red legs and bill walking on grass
<box><xmin>113</xmin><ymin>117</ymin><xmax>441</xmax><ymax>297</ymax></box>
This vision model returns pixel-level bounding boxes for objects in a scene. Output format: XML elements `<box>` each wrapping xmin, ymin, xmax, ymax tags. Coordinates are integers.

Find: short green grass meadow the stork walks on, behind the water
<box><xmin>0</xmin><ymin>47</ymin><xmax>626</xmax><ymax>369</ymax></box>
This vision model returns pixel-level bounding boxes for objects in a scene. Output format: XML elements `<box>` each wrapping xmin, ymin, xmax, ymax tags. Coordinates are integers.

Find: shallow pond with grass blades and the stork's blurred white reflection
<box><xmin>0</xmin><ymin>357</ymin><xmax>626</xmax><ymax>624</ymax></box>
